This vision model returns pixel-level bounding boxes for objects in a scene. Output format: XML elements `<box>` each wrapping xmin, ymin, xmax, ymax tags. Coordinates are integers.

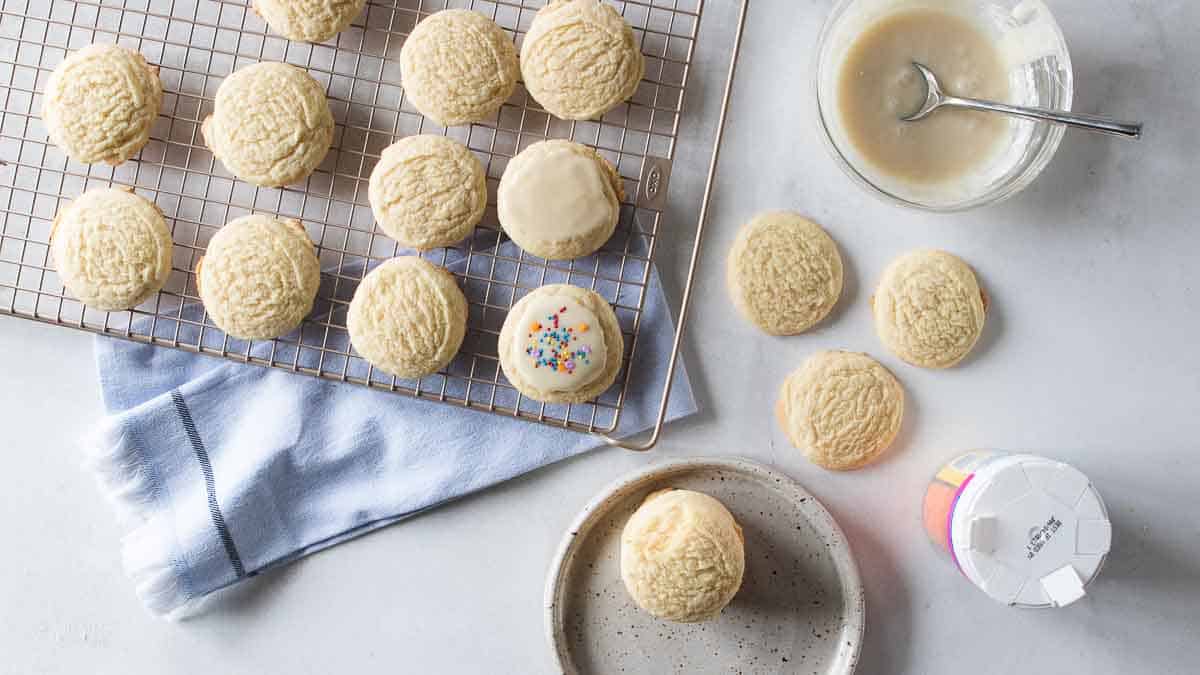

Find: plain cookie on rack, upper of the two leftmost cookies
<box><xmin>42</xmin><ymin>44</ymin><xmax>162</xmax><ymax>165</ymax></box>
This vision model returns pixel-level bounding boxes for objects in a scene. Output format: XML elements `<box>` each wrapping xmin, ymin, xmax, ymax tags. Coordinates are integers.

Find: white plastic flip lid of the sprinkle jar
<box><xmin>949</xmin><ymin>455</ymin><xmax>1112</xmax><ymax>608</ymax></box>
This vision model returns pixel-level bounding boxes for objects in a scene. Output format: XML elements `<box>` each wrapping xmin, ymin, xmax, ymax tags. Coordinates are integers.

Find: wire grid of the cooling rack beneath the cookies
<box><xmin>0</xmin><ymin>0</ymin><xmax>703</xmax><ymax>432</ymax></box>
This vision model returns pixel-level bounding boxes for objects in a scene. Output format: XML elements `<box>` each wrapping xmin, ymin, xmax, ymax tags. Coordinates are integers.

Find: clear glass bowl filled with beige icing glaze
<box><xmin>816</xmin><ymin>0</ymin><xmax>1074</xmax><ymax>211</ymax></box>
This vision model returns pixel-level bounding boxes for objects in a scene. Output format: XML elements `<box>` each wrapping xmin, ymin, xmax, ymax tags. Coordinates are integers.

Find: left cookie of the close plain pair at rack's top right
<box><xmin>400</xmin><ymin>10</ymin><xmax>521</xmax><ymax>126</ymax></box>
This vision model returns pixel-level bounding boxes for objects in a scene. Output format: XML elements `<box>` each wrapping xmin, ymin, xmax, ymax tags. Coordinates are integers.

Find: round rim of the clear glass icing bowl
<box><xmin>812</xmin><ymin>0</ymin><xmax>1075</xmax><ymax>214</ymax></box>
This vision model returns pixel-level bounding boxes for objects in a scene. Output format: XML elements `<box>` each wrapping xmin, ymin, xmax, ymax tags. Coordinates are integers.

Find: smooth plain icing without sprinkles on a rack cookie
<box><xmin>499</xmin><ymin>148</ymin><xmax>617</xmax><ymax>241</ymax></box>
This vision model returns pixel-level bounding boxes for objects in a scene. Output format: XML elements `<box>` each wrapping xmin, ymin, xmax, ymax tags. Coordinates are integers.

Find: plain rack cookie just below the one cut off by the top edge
<box><xmin>200</xmin><ymin>62</ymin><xmax>334</xmax><ymax>187</ymax></box>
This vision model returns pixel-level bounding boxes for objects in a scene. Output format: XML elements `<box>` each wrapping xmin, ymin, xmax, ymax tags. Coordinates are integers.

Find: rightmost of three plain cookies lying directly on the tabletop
<box><xmin>871</xmin><ymin>250</ymin><xmax>986</xmax><ymax>368</ymax></box>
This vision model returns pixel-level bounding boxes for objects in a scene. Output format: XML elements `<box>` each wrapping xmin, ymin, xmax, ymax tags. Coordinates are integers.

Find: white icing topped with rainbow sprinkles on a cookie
<box><xmin>512</xmin><ymin>295</ymin><xmax>607</xmax><ymax>392</ymax></box>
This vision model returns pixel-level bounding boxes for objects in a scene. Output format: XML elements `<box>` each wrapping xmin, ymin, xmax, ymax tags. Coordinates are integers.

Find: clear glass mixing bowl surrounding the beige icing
<box><xmin>816</xmin><ymin>0</ymin><xmax>1074</xmax><ymax>211</ymax></box>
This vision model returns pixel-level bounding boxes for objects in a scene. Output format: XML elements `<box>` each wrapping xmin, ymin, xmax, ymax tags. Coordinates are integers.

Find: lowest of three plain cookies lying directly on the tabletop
<box><xmin>775</xmin><ymin>352</ymin><xmax>904</xmax><ymax>471</ymax></box>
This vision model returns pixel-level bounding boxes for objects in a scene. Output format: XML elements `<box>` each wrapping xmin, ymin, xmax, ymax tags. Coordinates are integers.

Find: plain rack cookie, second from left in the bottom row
<box><xmin>196</xmin><ymin>214</ymin><xmax>320</xmax><ymax>340</ymax></box>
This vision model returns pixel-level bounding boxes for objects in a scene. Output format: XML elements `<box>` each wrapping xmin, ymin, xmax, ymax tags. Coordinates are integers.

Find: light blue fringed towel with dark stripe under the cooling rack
<box><xmin>88</xmin><ymin>267</ymin><xmax>696</xmax><ymax>617</ymax></box>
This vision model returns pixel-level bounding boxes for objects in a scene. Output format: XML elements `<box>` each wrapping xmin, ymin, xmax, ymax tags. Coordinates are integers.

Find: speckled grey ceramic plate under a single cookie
<box><xmin>546</xmin><ymin>458</ymin><xmax>864</xmax><ymax>675</ymax></box>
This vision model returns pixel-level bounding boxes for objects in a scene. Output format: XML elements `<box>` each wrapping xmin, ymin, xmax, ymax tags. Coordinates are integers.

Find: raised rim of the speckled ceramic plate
<box><xmin>544</xmin><ymin>456</ymin><xmax>866</xmax><ymax>675</ymax></box>
